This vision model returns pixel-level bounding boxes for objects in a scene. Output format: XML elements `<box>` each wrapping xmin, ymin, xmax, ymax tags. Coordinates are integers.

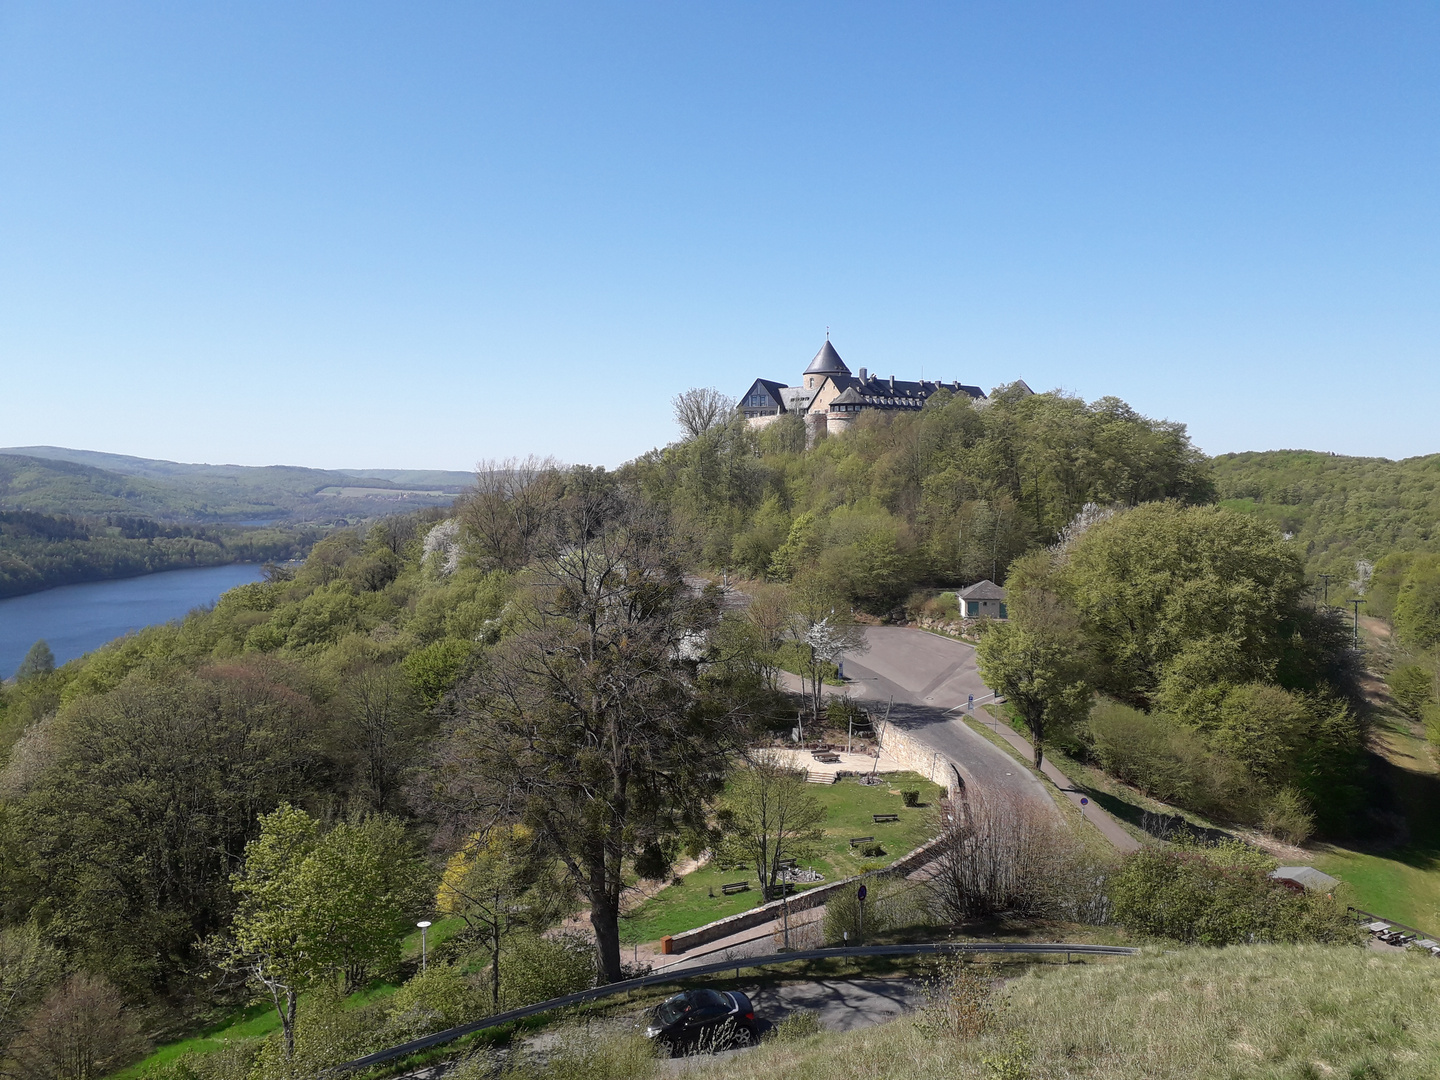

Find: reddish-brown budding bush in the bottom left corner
<box><xmin>10</xmin><ymin>972</ymin><xmax>144</xmax><ymax>1080</ymax></box>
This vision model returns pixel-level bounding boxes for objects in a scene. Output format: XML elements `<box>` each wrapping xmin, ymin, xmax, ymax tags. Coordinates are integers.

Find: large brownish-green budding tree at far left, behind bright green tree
<box><xmin>14</xmin><ymin>661</ymin><xmax>320</xmax><ymax>995</ymax></box>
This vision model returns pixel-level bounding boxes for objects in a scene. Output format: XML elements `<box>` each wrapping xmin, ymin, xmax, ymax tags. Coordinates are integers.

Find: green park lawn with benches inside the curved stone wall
<box><xmin>621</xmin><ymin>773</ymin><xmax>940</xmax><ymax>943</ymax></box>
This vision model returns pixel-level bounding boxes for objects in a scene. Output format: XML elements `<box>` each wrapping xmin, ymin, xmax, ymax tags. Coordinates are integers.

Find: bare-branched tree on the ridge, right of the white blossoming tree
<box><xmin>459</xmin><ymin>454</ymin><xmax>564</xmax><ymax>570</ymax></box>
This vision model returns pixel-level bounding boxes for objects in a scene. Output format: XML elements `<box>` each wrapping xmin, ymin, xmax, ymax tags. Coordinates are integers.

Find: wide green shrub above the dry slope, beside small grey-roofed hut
<box><xmin>1109</xmin><ymin>845</ymin><xmax>1358</xmax><ymax>945</ymax></box>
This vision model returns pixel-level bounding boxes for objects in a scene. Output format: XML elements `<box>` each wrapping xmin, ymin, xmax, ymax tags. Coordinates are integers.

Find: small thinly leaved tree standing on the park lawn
<box><xmin>719</xmin><ymin>752</ymin><xmax>825</xmax><ymax>897</ymax></box>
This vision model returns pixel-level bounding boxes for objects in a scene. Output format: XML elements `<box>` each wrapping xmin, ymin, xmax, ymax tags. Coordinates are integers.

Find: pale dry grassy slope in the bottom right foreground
<box><xmin>682</xmin><ymin>946</ymin><xmax>1440</xmax><ymax>1080</ymax></box>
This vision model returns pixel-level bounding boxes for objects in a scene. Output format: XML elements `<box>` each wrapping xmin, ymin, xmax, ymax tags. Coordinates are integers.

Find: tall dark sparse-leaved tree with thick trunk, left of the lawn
<box><xmin>432</xmin><ymin>472</ymin><xmax>732</xmax><ymax>981</ymax></box>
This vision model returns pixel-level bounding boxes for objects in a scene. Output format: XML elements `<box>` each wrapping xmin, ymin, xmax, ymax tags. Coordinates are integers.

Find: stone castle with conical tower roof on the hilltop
<box><xmin>737</xmin><ymin>334</ymin><xmax>1013</xmax><ymax>439</ymax></box>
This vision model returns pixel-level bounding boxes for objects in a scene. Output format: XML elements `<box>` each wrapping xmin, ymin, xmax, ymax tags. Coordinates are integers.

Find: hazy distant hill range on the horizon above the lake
<box><xmin>0</xmin><ymin>446</ymin><xmax>472</xmax><ymax>524</ymax></box>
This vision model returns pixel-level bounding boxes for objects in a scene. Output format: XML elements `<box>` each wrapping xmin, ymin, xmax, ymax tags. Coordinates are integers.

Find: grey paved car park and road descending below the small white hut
<box><xmin>845</xmin><ymin>626</ymin><xmax>1054</xmax><ymax>805</ymax></box>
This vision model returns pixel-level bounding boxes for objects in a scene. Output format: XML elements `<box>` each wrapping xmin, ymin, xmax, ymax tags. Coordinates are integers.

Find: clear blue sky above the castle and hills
<box><xmin>0</xmin><ymin>0</ymin><xmax>1440</xmax><ymax>468</ymax></box>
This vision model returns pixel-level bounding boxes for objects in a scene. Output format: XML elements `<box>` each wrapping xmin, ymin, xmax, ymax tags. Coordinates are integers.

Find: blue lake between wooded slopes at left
<box><xmin>0</xmin><ymin>563</ymin><xmax>264</xmax><ymax>678</ymax></box>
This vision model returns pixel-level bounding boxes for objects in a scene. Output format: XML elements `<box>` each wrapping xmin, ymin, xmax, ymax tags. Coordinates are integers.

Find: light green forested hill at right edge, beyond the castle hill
<box><xmin>1212</xmin><ymin>451</ymin><xmax>1440</xmax><ymax>600</ymax></box>
